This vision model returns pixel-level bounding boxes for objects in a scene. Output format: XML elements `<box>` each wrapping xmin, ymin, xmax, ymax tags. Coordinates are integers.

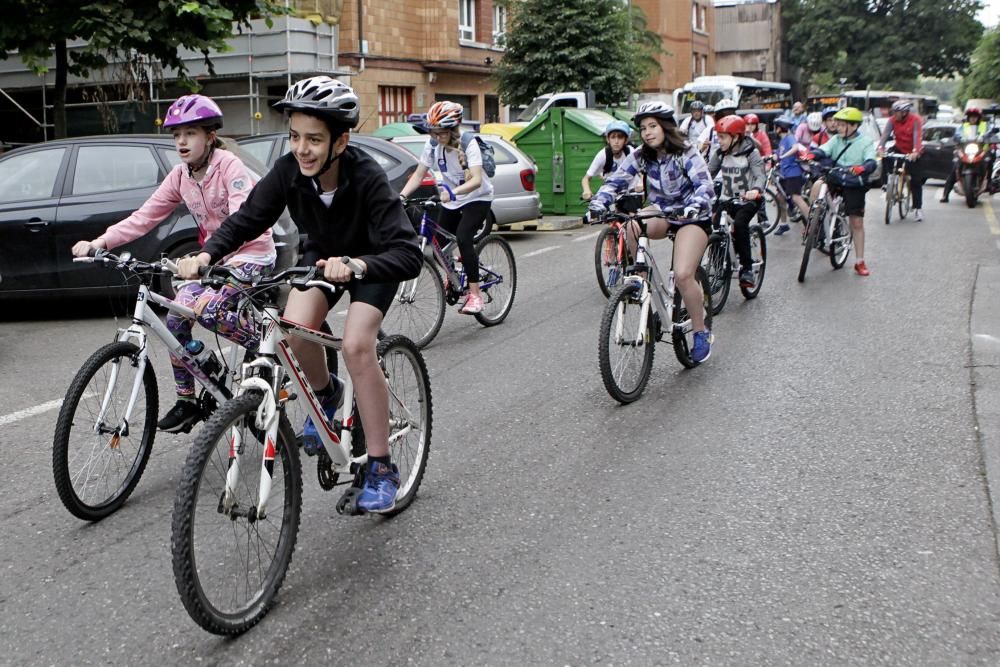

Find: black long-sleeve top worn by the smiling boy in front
<box><xmin>203</xmin><ymin>146</ymin><xmax>423</xmax><ymax>283</ymax></box>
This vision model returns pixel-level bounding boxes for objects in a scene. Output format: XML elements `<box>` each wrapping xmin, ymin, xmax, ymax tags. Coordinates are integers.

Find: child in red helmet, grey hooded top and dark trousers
<box><xmin>708</xmin><ymin>116</ymin><xmax>767</xmax><ymax>289</ymax></box>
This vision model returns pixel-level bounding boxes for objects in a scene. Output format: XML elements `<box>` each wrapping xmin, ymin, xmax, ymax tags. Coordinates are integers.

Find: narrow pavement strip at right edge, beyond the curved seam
<box><xmin>969</xmin><ymin>266</ymin><xmax>1000</xmax><ymax>553</ymax></box>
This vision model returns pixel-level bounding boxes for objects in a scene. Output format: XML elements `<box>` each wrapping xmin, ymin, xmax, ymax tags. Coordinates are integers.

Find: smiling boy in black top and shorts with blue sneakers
<box><xmin>180</xmin><ymin>76</ymin><xmax>423</xmax><ymax>512</ymax></box>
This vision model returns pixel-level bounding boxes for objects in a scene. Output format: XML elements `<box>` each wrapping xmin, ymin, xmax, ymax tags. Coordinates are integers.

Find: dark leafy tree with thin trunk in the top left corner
<box><xmin>0</xmin><ymin>0</ymin><xmax>285</xmax><ymax>137</ymax></box>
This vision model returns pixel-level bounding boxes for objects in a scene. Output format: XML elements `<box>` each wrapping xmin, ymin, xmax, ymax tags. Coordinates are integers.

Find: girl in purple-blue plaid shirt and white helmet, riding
<box><xmin>589</xmin><ymin>102</ymin><xmax>715</xmax><ymax>362</ymax></box>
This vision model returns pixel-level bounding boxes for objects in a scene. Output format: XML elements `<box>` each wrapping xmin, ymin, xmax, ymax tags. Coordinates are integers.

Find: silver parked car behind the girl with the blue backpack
<box><xmin>392</xmin><ymin>134</ymin><xmax>542</xmax><ymax>239</ymax></box>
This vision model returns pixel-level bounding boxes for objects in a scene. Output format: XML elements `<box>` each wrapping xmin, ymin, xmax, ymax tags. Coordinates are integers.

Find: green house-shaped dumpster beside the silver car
<box><xmin>514</xmin><ymin>108</ymin><xmax>614</xmax><ymax>215</ymax></box>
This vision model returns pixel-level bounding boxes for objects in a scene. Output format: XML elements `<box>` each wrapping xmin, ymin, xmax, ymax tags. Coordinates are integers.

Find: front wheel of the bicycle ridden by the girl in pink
<box><xmin>52</xmin><ymin>341</ymin><xmax>159</xmax><ymax>521</ymax></box>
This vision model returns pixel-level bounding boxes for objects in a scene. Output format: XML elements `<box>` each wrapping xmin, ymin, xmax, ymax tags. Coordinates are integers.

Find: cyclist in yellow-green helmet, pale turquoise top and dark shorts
<box><xmin>813</xmin><ymin>107</ymin><xmax>878</xmax><ymax>276</ymax></box>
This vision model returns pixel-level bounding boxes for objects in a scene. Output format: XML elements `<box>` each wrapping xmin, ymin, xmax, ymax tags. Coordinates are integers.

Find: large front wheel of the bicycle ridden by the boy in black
<box><xmin>170</xmin><ymin>392</ymin><xmax>302</xmax><ymax>635</ymax></box>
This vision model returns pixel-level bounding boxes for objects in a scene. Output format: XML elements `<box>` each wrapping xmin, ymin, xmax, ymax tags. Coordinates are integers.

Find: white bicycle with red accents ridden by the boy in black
<box><xmin>170</xmin><ymin>260</ymin><xmax>432</xmax><ymax>635</ymax></box>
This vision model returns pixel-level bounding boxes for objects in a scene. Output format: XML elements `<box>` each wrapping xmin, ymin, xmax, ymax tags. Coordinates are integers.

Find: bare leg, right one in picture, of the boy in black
<box><xmin>343</xmin><ymin>301</ymin><xmax>389</xmax><ymax>456</ymax></box>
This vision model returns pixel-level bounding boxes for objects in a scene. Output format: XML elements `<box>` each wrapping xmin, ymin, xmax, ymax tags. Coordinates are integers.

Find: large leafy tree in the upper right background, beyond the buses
<box><xmin>784</xmin><ymin>0</ymin><xmax>983</xmax><ymax>93</ymax></box>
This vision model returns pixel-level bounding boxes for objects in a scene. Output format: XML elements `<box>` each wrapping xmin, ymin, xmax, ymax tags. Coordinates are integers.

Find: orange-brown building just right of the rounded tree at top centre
<box><xmin>632</xmin><ymin>0</ymin><xmax>716</xmax><ymax>100</ymax></box>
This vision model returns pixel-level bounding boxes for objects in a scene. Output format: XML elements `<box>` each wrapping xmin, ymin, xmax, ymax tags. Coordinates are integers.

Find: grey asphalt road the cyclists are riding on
<box><xmin>0</xmin><ymin>184</ymin><xmax>1000</xmax><ymax>665</ymax></box>
